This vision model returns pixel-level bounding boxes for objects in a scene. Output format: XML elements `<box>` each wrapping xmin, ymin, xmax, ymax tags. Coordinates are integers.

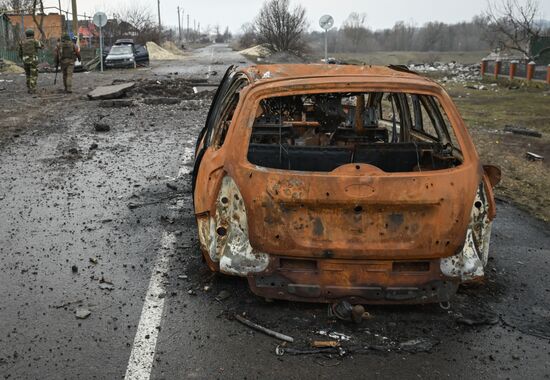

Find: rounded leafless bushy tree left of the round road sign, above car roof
<box><xmin>254</xmin><ymin>0</ymin><xmax>308</xmax><ymax>54</ymax></box>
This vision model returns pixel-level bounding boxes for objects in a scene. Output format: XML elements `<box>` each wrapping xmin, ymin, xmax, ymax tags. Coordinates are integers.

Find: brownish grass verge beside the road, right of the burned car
<box><xmin>444</xmin><ymin>78</ymin><xmax>550</xmax><ymax>221</ymax></box>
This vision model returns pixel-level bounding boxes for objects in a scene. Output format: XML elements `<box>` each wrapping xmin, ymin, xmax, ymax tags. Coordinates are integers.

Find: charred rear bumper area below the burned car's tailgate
<box><xmin>248</xmin><ymin>256</ymin><xmax>460</xmax><ymax>304</ymax></box>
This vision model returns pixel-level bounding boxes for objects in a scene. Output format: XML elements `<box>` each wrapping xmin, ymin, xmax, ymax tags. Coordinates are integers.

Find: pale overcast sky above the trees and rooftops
<box><xmin>44</xmin><ymin>0</ymin><xmax>550</xmax><ymax>32</ymax></box>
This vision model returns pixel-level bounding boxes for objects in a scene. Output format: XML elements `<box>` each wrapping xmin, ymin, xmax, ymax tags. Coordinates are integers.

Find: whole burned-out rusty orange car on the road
<box><xmin>193</xmin><ymin>65</ymin><xmax>500</xmax><ymax>304</ymax></box>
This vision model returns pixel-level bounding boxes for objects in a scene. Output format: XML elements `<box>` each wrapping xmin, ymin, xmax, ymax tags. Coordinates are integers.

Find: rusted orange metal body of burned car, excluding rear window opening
<box><xmin>194</xmin><ymin>65</ymin><xmax>500</xmax><ymax>303</ymax></box>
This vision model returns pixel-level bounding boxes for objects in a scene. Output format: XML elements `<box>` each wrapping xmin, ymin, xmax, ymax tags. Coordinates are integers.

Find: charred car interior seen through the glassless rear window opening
<box><xmin>248</xmin><ymin>92</ymin><xmax>462</xmax><ymax>172</ymax></box>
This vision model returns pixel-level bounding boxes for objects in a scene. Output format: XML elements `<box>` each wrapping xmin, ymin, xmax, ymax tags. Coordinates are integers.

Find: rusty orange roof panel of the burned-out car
<box><xmin>239</xmin><ymin>64</ymin><xmax>434</xmax><ymax>86</ymax></box>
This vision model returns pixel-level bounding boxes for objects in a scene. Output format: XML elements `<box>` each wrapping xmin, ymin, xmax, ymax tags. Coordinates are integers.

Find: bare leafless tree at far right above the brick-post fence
<box><xmin>485</xmin><ymin>0</ymin><xmax>541</xmax><ymax>58</ymax></box>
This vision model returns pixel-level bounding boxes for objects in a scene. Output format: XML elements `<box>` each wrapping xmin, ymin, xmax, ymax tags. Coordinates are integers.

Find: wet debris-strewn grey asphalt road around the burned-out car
<box><xmin>0</xmin><ymin>45</ymin><xmax>550</xmax><ymax>379</ymax></box>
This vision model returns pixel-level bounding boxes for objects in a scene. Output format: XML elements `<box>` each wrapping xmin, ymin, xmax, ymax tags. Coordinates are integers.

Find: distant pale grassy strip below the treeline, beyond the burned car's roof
<box><xmin>328</xmin><ymin>51</ymin><xmax>487</xmax><ymax>65</ymax></box>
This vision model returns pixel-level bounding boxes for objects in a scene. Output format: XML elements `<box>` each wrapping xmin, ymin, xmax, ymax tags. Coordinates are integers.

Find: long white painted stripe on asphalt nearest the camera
<box><xmin>124</xmin><ymin>231</ymin><xmax>176</xmax><ymax>380</ymax></box>
